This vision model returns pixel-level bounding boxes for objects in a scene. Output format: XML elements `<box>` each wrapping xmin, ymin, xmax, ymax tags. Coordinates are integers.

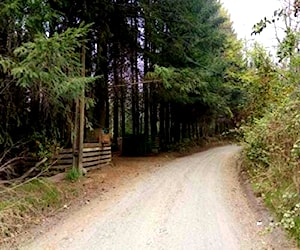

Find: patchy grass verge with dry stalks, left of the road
<box><xmin>0</xmin><ymin>179</ymin><xmax>81</xmax><ymax>246</ymax></box>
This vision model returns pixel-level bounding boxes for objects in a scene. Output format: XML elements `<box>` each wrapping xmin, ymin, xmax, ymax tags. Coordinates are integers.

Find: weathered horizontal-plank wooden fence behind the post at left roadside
<box><xmin>51</xmin><ymin>143</ymin><xmax>111</xmax><ymax>169</ymax></box>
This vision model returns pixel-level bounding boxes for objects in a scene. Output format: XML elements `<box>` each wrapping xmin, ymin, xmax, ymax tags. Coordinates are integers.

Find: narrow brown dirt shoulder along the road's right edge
<box><xmin>224</xmin><ymin>148</ymin><xmax>298</xmax><ymax>250</ymax></box>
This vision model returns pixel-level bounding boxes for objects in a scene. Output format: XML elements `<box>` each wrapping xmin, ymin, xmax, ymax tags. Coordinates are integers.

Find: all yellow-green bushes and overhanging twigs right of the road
<box><xmin>241</xmin><ymin>1</ymin><xmax>300</xmax><ymax>245</ymax></box>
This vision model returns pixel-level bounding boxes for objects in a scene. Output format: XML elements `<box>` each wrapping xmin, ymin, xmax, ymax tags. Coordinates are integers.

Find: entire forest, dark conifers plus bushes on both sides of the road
<box><xmin>0</xmin><ymin>0</ymin><xmax>300</xmax><ymax>244</ymax></box>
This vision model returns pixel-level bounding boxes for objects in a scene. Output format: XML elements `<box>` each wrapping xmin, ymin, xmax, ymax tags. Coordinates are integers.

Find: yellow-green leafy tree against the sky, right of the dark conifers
<box><xmin>231</xmin><ymin>44</ymin><xmax>292</xmax><ymax>122</ymax></box>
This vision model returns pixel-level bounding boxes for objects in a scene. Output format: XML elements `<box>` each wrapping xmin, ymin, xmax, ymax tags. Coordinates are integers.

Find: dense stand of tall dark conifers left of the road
<box><xmin>0</xmin><ymin>0</ymin><xmax>243</xmax><ymax>160</ymax></box>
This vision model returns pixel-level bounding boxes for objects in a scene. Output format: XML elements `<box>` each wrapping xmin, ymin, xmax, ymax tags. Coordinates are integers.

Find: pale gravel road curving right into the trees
<box><xmin>20</xmin><ymin>145</ymin><xmax>291</xmax><ymax>250</ymax></box>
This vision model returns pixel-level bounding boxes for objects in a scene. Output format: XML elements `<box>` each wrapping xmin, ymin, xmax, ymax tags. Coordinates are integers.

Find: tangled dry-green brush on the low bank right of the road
<box><xmin>243</xmin><ymin>101</ymin><xmax>300</xmax><ymax>245</ymax></box>
